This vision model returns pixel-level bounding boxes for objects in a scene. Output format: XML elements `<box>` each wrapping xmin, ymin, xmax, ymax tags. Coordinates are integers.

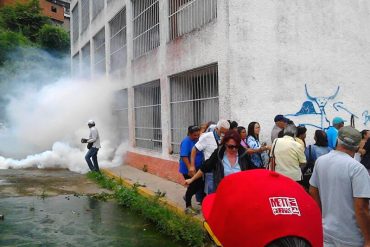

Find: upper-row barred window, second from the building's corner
<box><xmin>132</xmin><ymin>0</ymin><xmax>160</xmax><ymax>58</ymax></box>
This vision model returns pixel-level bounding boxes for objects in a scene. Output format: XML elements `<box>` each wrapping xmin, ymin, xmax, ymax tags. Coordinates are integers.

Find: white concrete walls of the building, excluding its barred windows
<box><xmin>71</xmin><ymin>0</ymin><xmax>370</xmax><ymax>180</ymax></box>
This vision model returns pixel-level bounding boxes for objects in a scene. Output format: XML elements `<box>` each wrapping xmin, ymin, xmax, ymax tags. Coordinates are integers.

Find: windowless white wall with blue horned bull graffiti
<box><xmin>228</xmin><ymin>0</ymin><xmax>370</xmax><ymax>144</ymax></box>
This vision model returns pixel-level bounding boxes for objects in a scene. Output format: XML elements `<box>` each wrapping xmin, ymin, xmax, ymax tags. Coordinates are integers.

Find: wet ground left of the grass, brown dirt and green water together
<box><xmin>0</xmin><ymin>169</ymin><xmax>185</xmax><ymax>247</ymax></box>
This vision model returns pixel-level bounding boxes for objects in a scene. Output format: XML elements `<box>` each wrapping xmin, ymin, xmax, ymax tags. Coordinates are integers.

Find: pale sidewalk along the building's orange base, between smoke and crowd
<box><xmin>103</xmin><ymin>165</ymin><xmax>200</xmax><ymax>211</ymax></box>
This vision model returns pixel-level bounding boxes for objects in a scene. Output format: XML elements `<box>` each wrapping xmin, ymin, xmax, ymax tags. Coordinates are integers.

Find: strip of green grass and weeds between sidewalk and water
<box><xmin>87</xmin><ymin>172</ymin><xmax>205</xmax><ymax>246</ymax></box>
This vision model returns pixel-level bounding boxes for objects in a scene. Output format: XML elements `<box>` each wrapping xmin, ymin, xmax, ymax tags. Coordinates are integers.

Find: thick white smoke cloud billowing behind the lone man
<box><xmin>0</xmin><ymin>52</ymin><xmax>127</xmax><ymax>173</ymax></box>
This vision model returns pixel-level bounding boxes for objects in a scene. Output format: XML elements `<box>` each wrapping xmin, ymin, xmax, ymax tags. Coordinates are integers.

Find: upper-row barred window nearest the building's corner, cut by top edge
<box><xmin>169</xmin><ymin>0</ymin><xmax>217</xmax><ymax>40</ymax></box>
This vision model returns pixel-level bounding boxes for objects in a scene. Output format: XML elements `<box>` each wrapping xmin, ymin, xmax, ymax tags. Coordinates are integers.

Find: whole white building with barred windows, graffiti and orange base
<box><xmin>71</xmin><ymin>0</ymin><xmax>370</xmax><ymax>181</ymax></box>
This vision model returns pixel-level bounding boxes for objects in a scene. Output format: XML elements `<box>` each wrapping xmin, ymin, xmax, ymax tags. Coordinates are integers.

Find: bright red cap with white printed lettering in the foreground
<box><xmin>202</xmin><ymin>169</ymin><xmax>323</xmax><ymax>247</ymax></box>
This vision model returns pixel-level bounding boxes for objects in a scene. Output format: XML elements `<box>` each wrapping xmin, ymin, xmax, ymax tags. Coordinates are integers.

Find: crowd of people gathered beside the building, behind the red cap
<box><xmin>179</xmin><ymin>115</ymin><xmax>370</xmax><ymax>247</ymax></box>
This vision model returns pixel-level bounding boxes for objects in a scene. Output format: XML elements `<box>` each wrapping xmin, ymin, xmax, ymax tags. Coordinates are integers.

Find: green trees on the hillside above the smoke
<box><xmin>0</xmin><ymin>0</ymin><xmax>69</xmax><ymax>66</ymax></box>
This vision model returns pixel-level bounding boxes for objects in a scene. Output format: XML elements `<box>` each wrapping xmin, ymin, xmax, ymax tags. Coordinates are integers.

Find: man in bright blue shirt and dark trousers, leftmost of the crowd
<box><xmin>179</xmin><ymin>125</ymin><xmax>204</xmax><ymax>214</ymax></box>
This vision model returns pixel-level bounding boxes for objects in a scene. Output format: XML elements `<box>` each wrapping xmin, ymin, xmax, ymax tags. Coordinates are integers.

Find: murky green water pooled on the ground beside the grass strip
<box><xmin>0</xmin><ymin>195</ymin><xmax>185</xmax><ymax>247</ymax></box>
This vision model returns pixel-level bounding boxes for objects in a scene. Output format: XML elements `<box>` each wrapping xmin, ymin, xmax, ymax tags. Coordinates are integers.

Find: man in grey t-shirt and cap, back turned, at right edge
<box><xmin>310</xmin><ymin>126</ymin><xmax>370</xmax><ymax>247</ymax></box>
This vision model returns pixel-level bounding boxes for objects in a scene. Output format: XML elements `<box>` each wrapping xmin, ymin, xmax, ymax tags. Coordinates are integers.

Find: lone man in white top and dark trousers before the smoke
<box><xmin>81</xmin><ymin>120</ymin><xmax>101</xmax><ymax>172</ymax></box>
